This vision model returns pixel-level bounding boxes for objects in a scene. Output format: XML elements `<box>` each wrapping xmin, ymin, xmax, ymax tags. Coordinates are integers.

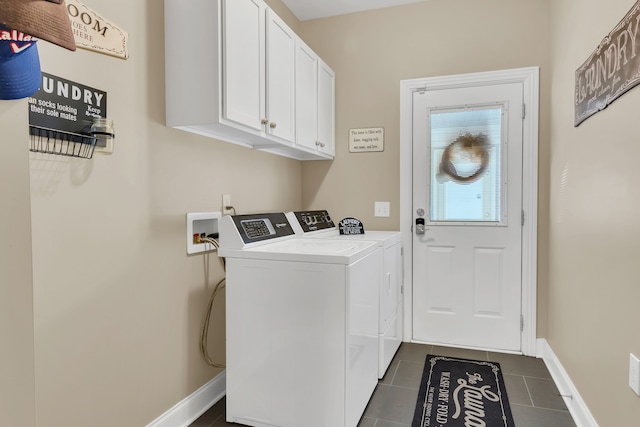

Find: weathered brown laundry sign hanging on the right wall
<box><xmin>574</xmin><ymin>0</ymin><xmax>640</xmax><ymax>126</ymax></box>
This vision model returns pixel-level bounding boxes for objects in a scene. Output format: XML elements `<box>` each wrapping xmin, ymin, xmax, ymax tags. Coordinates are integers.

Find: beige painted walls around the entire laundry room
<box><xmin>6</xmin><ymin>0</ymin><xmax>640</xmax><ymax>427</ymax></box>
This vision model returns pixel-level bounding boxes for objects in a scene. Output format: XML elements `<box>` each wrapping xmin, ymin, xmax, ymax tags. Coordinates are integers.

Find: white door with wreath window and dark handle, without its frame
<box><xmin>412</xmin><ymin>83</ymin><xmax>523</xmax><ymax>351</ymax></box>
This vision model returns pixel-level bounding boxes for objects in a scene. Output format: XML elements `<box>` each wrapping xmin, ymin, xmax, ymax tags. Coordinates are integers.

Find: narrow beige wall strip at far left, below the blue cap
<box><xmin>0</xmin><ymin>100</ymin><xmax>36</xmax><ymax>427</ymax></box>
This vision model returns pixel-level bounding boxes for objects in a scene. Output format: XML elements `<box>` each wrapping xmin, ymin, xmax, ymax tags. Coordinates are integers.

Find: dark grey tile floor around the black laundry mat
<box><xmin>190</xmin><ymin>343</ymin><xmax>576</xmax><ymax>427</ymax></box>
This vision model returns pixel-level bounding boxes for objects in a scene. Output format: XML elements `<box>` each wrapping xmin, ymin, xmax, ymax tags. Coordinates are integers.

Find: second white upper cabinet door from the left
<box><xmin>264</xmin><ymin>9</ymin><xmax>297</xmax><ymax>143</ymax></box>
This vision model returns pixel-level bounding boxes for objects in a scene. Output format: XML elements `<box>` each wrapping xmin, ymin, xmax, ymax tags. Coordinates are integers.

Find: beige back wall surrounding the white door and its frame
<box><xmin>300</xmin><ymin>0</ymin><xmax>551</xmax><ymax>336</ymax></box>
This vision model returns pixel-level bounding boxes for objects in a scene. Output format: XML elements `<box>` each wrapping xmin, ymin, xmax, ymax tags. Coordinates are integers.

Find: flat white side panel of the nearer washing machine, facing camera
<box><xmin>226</xmin><ymin>258</ymin><xmax>348</xmax><ymax>427</ymax></box>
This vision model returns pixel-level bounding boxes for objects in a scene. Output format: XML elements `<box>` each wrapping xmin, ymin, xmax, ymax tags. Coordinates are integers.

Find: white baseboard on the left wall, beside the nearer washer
<box><xmin>147</xmin><ymin>371</ymin><xmax>227</xmax><ymax>427</ymax></box>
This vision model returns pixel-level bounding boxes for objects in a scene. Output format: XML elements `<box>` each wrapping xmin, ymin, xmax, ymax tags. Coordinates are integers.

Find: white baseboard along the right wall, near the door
<box><xmin>537</xmin><ymin>338</ymin><xmax>598</xmax><ymax>427</ymax></box>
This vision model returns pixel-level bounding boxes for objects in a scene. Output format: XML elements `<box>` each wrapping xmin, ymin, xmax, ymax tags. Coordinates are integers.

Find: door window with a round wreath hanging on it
<box><xmin>426</xmin><ymin>104</ymin><xmax>506</xmax><ymax>225</ymax></box>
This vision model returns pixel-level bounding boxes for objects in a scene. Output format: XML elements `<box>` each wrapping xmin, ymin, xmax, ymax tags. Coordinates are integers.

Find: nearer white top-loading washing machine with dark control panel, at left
<box><xmin>218</xmin><ymin>213</ymin><xmax>382</xmax><ymax>427</ymax></box>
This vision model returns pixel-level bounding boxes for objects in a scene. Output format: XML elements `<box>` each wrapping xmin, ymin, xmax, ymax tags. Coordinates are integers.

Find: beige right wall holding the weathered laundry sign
<box><xmin>547</xmin><ymin>0</ymin><xmax>640</xmax><ymax>427</ymax></box>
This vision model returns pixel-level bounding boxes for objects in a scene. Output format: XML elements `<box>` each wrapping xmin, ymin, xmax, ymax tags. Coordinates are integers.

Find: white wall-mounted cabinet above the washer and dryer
<box><xmin>165</xmin><ymin>0</ymin><xmax>335</xmax><ymax>160</ymax></box>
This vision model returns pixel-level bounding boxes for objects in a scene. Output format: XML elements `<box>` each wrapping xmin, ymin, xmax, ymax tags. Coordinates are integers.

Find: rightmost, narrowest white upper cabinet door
<box><xmin>318</xmin><ymin>59</ymin><xmax>336</xmax><ymax>156</ymax></box>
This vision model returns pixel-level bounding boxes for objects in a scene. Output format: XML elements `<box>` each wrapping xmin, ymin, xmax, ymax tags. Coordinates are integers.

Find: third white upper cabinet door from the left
<box><xmin>296</xmin><ymin>39</ymin><xmax>318</xmax><ymax>150</ymax></box>
